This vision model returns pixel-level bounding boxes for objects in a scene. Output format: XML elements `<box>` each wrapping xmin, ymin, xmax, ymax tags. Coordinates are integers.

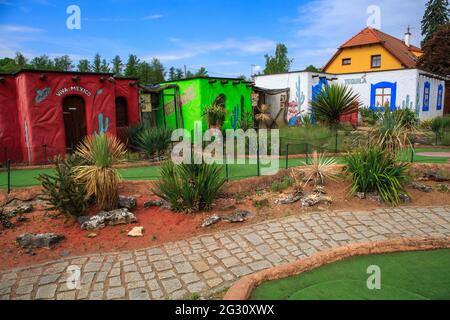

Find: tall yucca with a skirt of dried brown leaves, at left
<box><xmin>75</xmin><ymin>134</ymin><xmax>126</xmax><ymax>211</ymax></box>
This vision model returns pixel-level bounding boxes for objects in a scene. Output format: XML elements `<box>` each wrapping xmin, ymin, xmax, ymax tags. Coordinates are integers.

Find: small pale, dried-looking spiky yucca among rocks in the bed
<box><xmin>294</xmin><ymin>151</ymin><xmax>341</xmax><ymax>186</ymax></box>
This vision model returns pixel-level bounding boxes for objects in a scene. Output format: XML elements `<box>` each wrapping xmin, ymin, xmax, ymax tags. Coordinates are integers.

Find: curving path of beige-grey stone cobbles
<box><xmin>0</xmin><ymin>207</ymin><xmax>450</xmax><ymax>300</ymax></box>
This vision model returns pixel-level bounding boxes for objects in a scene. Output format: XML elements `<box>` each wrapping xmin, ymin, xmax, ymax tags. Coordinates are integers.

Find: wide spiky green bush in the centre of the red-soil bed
<box><xmin>153</xmin><ymin>162</ymin><xmax>225</xmax><ymax>213</ymax></box>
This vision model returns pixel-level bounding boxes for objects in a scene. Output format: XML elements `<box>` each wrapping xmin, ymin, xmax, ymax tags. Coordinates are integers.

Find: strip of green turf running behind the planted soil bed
<box><xmin>0</xmin><ymin>148</ymin><xmax>450</xmax><ymax>189</ymax></box>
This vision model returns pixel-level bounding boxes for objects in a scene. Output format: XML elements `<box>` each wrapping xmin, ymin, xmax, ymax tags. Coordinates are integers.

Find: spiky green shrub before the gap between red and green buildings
<box><xmin>137</xmin><ymin>128</ymin><xmax>172</xmax><ymax>157</ymax></box>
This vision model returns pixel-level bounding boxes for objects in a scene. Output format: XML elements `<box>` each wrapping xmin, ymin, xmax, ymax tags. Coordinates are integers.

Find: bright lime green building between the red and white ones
<box><xmin>143</xmin><ymin>77</ymin><xmax>252</xmax><ymax>131</ymax></box>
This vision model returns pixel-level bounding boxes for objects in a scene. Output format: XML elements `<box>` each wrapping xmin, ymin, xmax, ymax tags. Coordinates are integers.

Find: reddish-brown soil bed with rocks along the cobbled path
<box><xmin>0</xmin><ymin>165</ymin><xmax>450</xmax><ymax>270</ymax></box>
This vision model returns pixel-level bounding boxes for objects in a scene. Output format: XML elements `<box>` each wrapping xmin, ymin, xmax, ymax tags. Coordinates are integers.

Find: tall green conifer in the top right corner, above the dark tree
<box><xmin>422</xmin><ymin>0</ymin><xmax>450</xmax><ymax>46</ymax></box>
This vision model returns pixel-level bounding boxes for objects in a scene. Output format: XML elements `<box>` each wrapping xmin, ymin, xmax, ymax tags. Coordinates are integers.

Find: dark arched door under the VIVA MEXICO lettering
<box><xmin>63</xmin><ymin>96</ymin><xmax>86</xmax><ymax>152</ymax></box>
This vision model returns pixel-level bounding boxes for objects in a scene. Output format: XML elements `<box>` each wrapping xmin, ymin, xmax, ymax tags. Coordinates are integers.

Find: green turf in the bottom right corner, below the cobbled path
<box><xmin>251</xmin><ymin>250</ymin><xmax>450</xmax><ymax>300</ymax></box>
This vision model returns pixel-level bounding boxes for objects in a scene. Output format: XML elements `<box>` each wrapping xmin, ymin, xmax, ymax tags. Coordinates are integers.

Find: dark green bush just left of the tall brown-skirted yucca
<box><xmin>38</xmin><ymin>155</ymin><xmax>88</xmax><ymax>217</ymax></box>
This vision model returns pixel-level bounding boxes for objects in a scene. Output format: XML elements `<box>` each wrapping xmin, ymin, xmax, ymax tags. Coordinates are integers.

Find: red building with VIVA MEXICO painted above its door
<box><xmin>0</xmin><ymin>70</ymin><xmax>139</xmax><ymax>164</ymax></box>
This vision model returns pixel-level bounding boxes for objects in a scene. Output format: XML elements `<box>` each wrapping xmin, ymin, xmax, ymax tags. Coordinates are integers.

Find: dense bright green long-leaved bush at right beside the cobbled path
<box><xmin>345</xmin><ymin>146</ymin><xmax>408</xmax><ymax>205</ymax></box>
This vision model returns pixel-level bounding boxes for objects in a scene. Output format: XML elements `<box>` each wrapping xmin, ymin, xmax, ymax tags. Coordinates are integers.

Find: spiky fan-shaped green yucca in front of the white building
<box><xmin>311</xmin><ymin>84</ymin><xmax>361</xmax><ymax>128</ymax></box>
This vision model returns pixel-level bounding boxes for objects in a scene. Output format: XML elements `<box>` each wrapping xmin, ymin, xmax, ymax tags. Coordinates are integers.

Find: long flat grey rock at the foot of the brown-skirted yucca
<box><xmin>78</xmin><ymin>208</ymin><xmax>137</xmax><ymax>230</ymax></box>
